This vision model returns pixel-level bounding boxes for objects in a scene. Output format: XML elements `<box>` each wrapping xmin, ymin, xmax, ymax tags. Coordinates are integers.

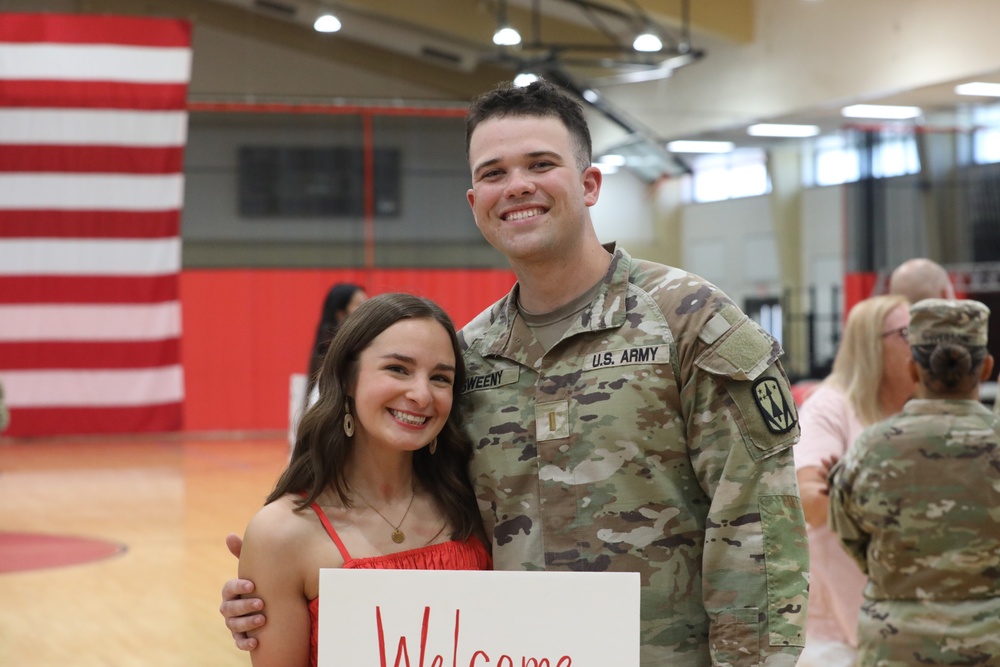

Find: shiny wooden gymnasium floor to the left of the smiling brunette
<box><xmin>0</xmin><ymin>432</ymin><xmax>288</xmax><ymax>667</ymax></box>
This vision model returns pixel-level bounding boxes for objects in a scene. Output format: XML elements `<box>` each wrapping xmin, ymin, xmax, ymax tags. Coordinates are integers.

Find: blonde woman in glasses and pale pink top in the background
<box><xmin>794</xmin><ymin>295</ymin><xmax>914</xmax><ymax>667</ymax></box>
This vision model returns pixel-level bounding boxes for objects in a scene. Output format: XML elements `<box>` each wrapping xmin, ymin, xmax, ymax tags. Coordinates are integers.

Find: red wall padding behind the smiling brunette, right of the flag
<box><xmin>180</xmin><ymin>269</ymin><xmax>515</xmax><ymax>431</ymax></box>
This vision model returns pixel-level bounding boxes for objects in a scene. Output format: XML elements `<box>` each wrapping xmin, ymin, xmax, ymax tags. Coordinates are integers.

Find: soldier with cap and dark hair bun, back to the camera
<box><xmin>830</xmin><ymin>299</ymin><xmax>1000</xmax><ymax>667</ymax></box>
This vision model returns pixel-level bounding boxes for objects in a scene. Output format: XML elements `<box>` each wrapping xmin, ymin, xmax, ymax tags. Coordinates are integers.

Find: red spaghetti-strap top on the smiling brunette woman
<box><xmin>309</xmin><ymin>503</ymin><xmax>493</xmax><ymax>667</ymax></box>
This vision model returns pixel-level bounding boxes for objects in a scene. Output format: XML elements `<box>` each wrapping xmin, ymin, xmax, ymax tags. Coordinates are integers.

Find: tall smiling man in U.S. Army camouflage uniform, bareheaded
<box><xmin>222</xmin><ymin>82</ymin><xmax>808</xmax><ymax>667</ymax></box>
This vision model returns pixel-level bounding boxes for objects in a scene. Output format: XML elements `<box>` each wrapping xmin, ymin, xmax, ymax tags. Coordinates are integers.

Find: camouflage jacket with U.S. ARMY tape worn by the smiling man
<box><xmin>460</xmin><ymin>248</ymin><xmax>808</xmax><ymax>667</ymax></box>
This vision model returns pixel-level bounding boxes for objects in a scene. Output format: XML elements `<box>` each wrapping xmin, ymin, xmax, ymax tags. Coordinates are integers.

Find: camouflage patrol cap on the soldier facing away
<box><xmin>910</xmin><ymin>299</ymin><xmax>990</xmax><ymax>347</ymax></box>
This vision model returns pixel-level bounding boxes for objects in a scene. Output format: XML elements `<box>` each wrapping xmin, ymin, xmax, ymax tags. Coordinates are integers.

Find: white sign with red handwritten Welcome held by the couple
<box><xmin>319</xmin><ymin>569</ymin><xmax>639</xmax><ymax>667</ymax></box>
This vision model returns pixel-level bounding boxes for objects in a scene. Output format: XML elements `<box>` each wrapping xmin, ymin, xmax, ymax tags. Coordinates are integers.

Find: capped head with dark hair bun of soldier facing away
<box><xmin>910</xmin><ymin>299</ymin><xmax>990</xmax><ymax>394</ymax></box>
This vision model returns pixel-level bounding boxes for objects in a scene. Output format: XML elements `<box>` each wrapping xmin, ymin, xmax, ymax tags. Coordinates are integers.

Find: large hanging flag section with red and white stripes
<box><xmin>0</xmin><ymin>14</ymin><xmax>191</xmax><ymax>436</ymax></box>
